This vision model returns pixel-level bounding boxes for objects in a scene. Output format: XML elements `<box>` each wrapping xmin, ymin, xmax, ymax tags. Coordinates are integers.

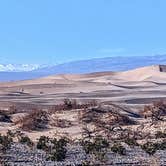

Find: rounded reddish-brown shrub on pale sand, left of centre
<box><xmin>20</xmin><ymin>109</ymin><xmax>49</xmax><ymax>130</ymax></box>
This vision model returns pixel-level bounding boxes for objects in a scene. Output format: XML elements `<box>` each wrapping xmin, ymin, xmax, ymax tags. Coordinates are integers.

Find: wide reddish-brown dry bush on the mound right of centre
<box><xmin>79</xmin><ymin>107</ymin><xmax>136</xmax><ymax>139</ymax></box>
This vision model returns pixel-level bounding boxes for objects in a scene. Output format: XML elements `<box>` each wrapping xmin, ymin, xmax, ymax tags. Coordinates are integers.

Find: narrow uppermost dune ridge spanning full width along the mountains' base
<box><xmin>0</xmin><ymin>65</ymin><xmax>166</xmax><ymax>86</ymax></box>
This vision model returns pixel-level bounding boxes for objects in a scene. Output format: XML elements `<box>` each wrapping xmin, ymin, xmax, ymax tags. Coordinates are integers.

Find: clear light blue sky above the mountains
<box><xmin>0</xmin><ymin>0</ymin><xmax>166</xmax><ymax>64</ymax></box>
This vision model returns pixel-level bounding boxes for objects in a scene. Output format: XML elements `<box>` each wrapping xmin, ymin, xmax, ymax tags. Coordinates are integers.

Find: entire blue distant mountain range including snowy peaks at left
<box><xmin>0</xmin><ymin>55</ymin><xmax>166</xmax><ymax>81</ymax></box>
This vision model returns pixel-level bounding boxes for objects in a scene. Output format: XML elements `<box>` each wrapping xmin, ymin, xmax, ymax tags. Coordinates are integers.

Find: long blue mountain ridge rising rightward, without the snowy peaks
<box><xmin>36</xmin><ymin>55</ymin><xmax>166</xmax><ymax>74</ymax></box>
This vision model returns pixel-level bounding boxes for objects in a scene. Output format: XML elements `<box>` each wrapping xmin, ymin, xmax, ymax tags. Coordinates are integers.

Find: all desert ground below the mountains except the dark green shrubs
<box><xmin>0</xmin><ymin>65</ymin><xmax>166</xmax><ymax>166</ymax></box>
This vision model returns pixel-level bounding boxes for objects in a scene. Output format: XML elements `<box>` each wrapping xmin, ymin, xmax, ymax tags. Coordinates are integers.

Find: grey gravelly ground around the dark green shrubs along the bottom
<box><xmin>1</xmin><ymin>143</ymin><xmax>166</xmax><ymax>166</ymax></box>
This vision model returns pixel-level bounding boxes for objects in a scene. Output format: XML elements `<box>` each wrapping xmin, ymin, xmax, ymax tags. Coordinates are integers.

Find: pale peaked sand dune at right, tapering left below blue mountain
<box><xmin>60</xmin><ymin>65</ymin><xmax>166</xmax><ymax>82</ymax></box>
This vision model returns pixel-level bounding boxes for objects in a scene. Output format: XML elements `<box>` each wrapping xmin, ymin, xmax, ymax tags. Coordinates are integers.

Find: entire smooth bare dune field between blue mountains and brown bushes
<box><xmin>0</xmin><ymin>65</ymin><xmax>166</xmax><ymax>105</ymax></box>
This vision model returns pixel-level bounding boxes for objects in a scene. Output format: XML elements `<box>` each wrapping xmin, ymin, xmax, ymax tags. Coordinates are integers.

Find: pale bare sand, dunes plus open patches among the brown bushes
<box><xmin>0</xmin><ymin>66</ymin><xmax>166</xmax><ymax>140</ymax></box>
